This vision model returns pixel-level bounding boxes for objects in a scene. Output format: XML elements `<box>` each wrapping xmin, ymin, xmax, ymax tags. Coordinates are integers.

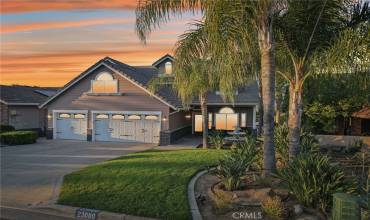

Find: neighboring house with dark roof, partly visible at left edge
<box><xmin>0</xmin><ymin>85</ymin><xmax>57</xmax><ymax>134</ymax></box>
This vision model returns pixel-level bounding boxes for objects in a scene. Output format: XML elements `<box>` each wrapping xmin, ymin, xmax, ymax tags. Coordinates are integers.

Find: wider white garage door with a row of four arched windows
<box><xmin>94</xmin><ymin>113</ymin><xmax>161</xmax><ymax>143</ymax></box>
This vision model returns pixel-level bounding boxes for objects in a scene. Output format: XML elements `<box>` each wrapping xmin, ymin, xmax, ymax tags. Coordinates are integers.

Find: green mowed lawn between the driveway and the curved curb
<box><xmin>58</xmin><ymin>149</ymin><xmax>225</xmax><ymax>220</ymax></box>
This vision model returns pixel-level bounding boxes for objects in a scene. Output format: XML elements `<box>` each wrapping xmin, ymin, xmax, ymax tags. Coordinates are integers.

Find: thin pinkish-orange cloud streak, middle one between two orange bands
<box><xmin>1</xmin><ymin>18</ymin><xmax>133</xmax><ymax>33</ymax></box>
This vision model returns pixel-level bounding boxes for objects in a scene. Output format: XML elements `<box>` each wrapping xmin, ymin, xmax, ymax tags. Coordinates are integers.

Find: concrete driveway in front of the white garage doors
<box><xmin>0</xmin><ymin>139</ymin><xmax>155</xmax><ymax>208</ymax></box>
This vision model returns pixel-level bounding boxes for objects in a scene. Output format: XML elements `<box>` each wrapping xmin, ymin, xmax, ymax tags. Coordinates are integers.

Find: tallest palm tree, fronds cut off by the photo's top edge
<box><xmin>136</xmin><ymin>0</ymin><xmax>278</xmax><ymax>176</ymax></box>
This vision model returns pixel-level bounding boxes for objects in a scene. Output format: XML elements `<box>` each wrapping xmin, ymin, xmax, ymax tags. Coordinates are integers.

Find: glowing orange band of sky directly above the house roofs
<box><xmin>0</xmin><ymin>44</ymin><xmax>172</xmax><ymax>86</ymax></box>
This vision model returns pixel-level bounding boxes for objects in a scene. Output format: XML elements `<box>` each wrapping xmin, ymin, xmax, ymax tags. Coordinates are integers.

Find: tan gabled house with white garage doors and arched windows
<box><xmin>39</xmin><ymin>55</ymin><xmax>258</xmax><ymax>145</ymax></box>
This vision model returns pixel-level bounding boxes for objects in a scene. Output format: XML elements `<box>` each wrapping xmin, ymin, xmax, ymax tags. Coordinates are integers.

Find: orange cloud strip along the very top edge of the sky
<box><xmin>1</xmin><ymin>0</ymin><xmax>137</xmax><ymax>13</ymax></box>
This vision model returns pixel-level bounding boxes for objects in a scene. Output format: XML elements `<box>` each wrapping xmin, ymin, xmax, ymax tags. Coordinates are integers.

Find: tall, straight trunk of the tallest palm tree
<box><xmin>258</xmin><ymin>16</ymin><xmax>276</xmax><ymax>177</ymax></box>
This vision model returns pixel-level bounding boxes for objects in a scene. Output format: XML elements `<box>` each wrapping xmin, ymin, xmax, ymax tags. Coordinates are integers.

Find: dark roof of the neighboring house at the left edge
<box><xmin>0</xmin><ymin>85</ymin><xmax>59</xmax><ymax>105</ymax></box>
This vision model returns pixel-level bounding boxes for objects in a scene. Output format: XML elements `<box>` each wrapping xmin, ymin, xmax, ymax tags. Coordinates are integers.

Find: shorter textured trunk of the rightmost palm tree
<box><xmin>288</xmin><ymin>83</ymin><xmax>302</xmax><ymax>160</ymax></box>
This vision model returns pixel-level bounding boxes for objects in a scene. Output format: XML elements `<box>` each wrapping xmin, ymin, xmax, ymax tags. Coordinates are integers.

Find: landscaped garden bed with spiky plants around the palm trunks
<box><xmin>199</xmin><ymin>126</ymin><xmax>370</xmax><ymax>220</ymax></box>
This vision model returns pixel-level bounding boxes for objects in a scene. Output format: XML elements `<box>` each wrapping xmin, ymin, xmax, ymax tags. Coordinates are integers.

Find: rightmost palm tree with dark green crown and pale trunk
<box><xmin>276</xmin><ymin>0</ymin><xmax>366</xmax><ymax>159</ymax></box>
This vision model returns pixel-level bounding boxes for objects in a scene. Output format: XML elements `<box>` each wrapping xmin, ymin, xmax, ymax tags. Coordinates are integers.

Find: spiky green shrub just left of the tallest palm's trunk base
<box><xmin>215</xmin><ymin>137</ymin><xmax>258</xmax><ymax>191</ymax></box>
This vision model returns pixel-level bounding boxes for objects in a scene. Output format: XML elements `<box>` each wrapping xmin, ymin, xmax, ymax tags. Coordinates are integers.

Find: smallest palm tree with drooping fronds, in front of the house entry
<box><xmin>150</xmin><ymin>22</ymin><xmax>217</xmax><ymax>148</ymax></box>
